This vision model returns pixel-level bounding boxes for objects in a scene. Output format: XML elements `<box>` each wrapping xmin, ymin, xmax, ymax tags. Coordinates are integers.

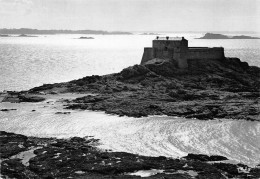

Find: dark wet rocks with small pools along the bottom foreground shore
<box><xmin>0</xmin><ymin>131</ymin><xmax>260</xmax><ymax>179</ymax></box>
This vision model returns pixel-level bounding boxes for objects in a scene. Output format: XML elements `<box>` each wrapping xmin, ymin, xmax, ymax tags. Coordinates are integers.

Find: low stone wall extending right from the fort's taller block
<box><xmin>187</xmin><ymin>47</ymin><xmax>225</xmax><ymax>59</ymax></box>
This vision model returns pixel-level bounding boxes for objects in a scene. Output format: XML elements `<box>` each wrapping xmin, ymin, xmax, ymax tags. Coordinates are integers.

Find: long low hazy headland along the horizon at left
<box><xmin>0</xmin><ymin>28</ymin><xmax>132</xmax><ymax>35</ymax></box>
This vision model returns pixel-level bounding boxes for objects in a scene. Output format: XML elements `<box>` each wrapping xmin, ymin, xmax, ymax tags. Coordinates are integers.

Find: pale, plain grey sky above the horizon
<box><xmin>0</xmin><ymin>0</ymin><xmax>260</xmax><ymax>32</ymax></box>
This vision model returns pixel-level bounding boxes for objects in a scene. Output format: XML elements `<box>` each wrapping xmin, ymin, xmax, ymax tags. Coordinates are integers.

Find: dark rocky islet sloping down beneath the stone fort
<box><xmin>5</xmin><ymin>58</ymin><xmax>260</xmax><ymax>121</ymax></box>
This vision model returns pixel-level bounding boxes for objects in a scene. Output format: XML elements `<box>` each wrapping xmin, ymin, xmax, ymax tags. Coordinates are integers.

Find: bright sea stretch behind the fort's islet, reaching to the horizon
<box><xmin>0</xmin><ymin>34</ymin><xmax>260</xmax><ymax>91</ymax></box>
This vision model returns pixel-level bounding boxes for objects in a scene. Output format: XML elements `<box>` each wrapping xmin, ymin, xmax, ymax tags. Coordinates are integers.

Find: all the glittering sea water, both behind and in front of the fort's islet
<box><xmin>0</xmin><ymin>33</ymin><xmax>260</xmax><ymax>166</ymax></box>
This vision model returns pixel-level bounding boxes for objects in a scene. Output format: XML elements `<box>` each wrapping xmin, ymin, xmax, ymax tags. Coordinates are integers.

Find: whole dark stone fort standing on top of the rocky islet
<box><xmin>141</xmin><ymin>36</ymin><xmax>225</xmax><ymax>68</ymax></box>
